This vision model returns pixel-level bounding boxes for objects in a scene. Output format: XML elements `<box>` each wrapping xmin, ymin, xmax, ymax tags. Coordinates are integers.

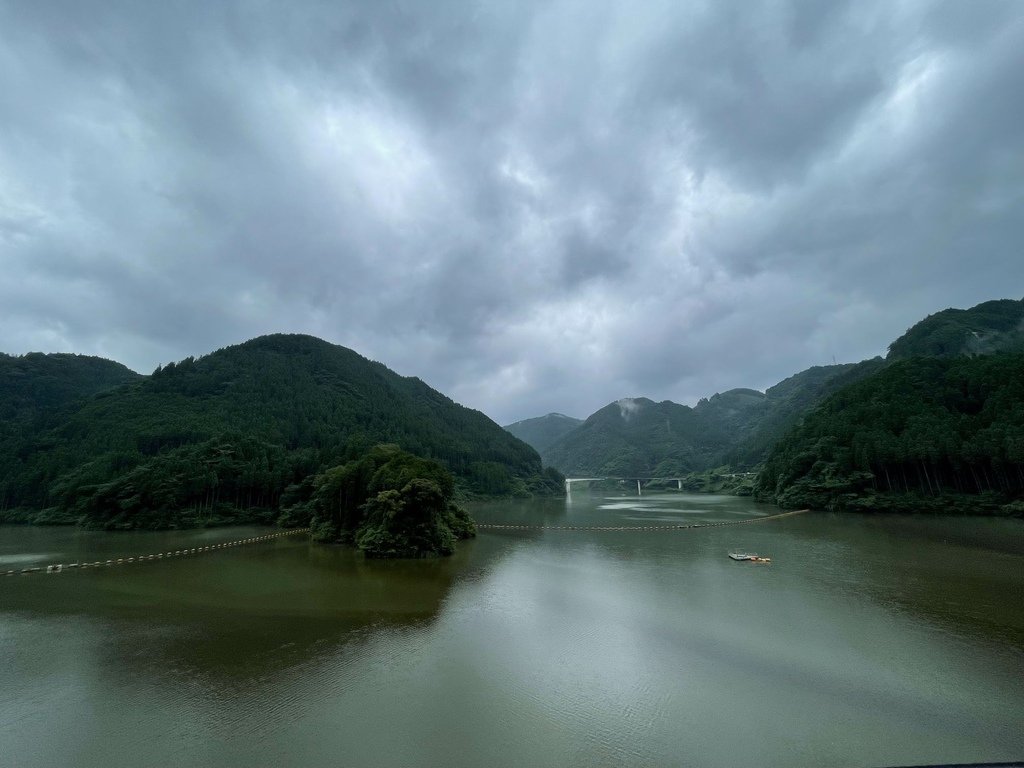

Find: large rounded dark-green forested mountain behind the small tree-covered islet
<box><xmin>0</xmin><ymin>335</ymin><xmax>561</xmax><ymax>527</ymax></box>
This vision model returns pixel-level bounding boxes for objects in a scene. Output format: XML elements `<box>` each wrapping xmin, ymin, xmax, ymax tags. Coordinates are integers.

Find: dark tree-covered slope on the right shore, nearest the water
<box><xmin>757</xmin><ymin>353</ymin><xmax>1024</xmax><ymax>514</ymax></box>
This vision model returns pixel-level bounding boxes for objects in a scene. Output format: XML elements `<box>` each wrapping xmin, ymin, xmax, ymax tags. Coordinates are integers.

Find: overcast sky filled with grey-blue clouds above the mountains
<box><xmin>0</xmin><ymin>0</ymin><xmax>1024</xmax><ymax>423</ymax></box>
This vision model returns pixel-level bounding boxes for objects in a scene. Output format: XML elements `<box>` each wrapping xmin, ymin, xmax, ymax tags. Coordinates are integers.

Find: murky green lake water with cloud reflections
<box><xmin>0</xmin><ymin>493</ymin><xmax>1024</xmax><ymax>768</ymax></box>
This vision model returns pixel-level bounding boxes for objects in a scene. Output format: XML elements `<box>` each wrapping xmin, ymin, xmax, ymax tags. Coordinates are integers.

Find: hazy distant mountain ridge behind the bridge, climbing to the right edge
<box><xmin>532</xmin><ymin>299</ymin><xmax>1024</xmax><ymax>475</ymax></box>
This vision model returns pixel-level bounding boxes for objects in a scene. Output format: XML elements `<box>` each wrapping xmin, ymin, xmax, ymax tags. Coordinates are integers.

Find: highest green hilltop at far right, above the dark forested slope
<box><xmin>889</xmin><ymin>299</ymin><xmax>1024</xmax><ymax>360</ymax></box>
